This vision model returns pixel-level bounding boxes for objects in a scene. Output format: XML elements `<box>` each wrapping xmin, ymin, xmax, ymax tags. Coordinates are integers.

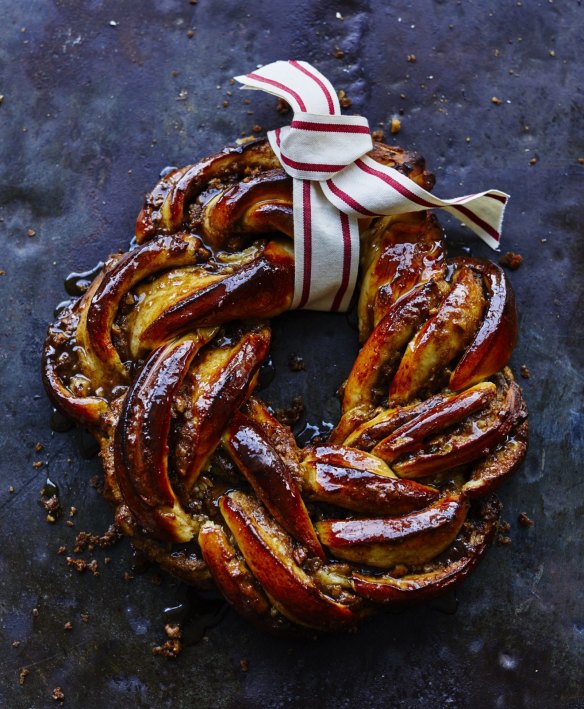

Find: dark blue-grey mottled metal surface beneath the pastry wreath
<box><xmin>0</xmin><ymin>0</ymin><xmax>584</xmax><ymax>708</ymax></box>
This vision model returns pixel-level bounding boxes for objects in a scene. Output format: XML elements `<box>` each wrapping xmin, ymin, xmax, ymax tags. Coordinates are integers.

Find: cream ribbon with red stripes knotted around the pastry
<box><xmin>235</xmin><ymin>61</ymin><xmax>509</xmax><ymax>312</ymax></box>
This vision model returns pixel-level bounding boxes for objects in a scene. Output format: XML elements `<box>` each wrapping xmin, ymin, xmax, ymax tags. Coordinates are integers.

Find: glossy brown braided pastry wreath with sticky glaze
<box><xmin>43</xmin><ymin>140</ymin><xmax>527</xmax><ymax>630</ymax></box>
